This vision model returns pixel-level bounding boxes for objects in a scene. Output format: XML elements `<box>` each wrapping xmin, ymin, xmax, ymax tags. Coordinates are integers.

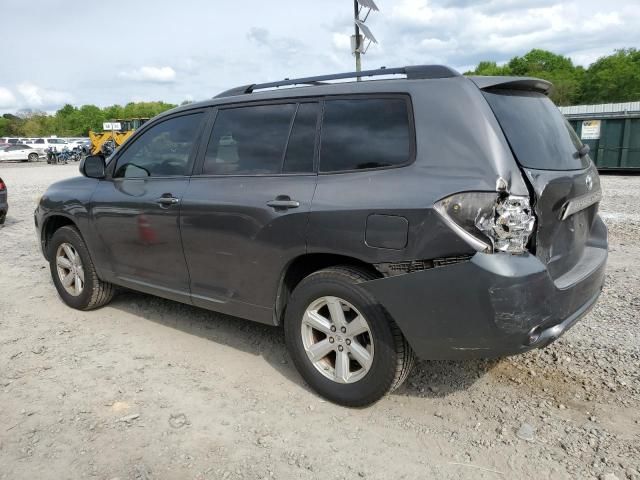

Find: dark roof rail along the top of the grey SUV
<box><xmin>213</xmin><ymin>65</ymin><xmax>460</xmax><ymax>98</ymax></box>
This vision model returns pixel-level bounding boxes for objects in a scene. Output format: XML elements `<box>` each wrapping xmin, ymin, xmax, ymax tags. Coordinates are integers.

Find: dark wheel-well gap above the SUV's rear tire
<box><xmin>274</xmin><ymin>253</ymin><xmax>382</xmax><ymax>325</ymax></box>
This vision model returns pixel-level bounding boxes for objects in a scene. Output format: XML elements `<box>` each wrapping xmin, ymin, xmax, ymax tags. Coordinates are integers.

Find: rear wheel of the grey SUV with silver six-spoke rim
<box><xmin>284</xmin><ymin>266</ymin><xmax>415</xmax><ymax>407</ymax></box>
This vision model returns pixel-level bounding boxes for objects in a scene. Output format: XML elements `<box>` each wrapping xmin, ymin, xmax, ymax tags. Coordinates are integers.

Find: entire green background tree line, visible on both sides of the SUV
<box><xmin>0</xmin><ymin>48</ymin><xmax>640</xmax><ymax>137</ymax></box>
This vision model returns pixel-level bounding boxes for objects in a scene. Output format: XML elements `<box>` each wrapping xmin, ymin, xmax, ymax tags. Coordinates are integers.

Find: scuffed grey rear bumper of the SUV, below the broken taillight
<box><xmin>361</xmin><ymin>244</ymin><xmax>607</xmax><ymax>360</ymax></box>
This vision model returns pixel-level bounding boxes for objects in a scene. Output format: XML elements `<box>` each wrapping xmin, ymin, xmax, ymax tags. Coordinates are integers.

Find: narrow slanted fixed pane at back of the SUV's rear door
<box><xmin>283</xmin><ymin>103</ymin><xmax>320</xmax><ymax>173</ymax></box>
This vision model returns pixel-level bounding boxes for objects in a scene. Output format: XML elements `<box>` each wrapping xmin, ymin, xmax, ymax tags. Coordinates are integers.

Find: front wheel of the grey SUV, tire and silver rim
<box><xmin>47</xmin><ymin>226</ymin><xmax>115</xmax><ymax>310</ymax></box>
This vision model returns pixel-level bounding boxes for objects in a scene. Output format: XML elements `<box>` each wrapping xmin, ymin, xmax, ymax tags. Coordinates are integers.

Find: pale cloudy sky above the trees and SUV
<box><xmin>0</xmin><ymin>0</ymin><xmax>640</xmax><ymax>112</ymax></box>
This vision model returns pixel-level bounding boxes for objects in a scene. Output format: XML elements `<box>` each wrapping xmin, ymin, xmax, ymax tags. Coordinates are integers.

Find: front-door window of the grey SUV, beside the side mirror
<box><xmin>114</xmin><ymin>113</ymin><xmax>202</xmax><ymax>178</ymax></box>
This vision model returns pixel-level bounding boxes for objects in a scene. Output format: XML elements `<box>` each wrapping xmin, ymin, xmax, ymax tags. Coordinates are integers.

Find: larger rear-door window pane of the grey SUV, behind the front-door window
<box><xmin>202</xmin><ymin>104</ymin><xmax>296</xmax><ymax>175</ymax></box>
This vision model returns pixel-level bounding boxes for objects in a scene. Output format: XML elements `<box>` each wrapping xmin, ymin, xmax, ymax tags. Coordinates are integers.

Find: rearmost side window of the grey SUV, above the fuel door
<box><xmin>320</xmin><ymin>98</ymin><xmax>411</xmax><ymax>172</ymax></box>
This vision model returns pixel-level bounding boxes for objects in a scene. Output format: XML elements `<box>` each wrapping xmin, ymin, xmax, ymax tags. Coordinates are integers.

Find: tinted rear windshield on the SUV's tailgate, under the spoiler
<box><xmin>483</xmin><ymin>90</ymin><xmax>589</xmax><ymax>170</ymax></box>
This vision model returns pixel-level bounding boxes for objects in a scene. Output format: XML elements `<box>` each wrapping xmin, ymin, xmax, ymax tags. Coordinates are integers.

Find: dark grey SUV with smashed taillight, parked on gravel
<box><xmin>35</xmin><ymin>66</ymin><xmax>607</xmax><ymax>406</ymax></box>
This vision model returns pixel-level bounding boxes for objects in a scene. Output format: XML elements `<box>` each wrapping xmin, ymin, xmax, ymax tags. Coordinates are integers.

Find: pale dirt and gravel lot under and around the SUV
<box><xmin>0</xmin><ymin>163</ymin><xmax>640</xmax><ymax>480</ymax></box>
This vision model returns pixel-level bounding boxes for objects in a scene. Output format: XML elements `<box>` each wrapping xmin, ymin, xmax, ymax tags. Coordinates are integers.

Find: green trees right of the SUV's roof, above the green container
<box><xmin>465</xmin><ymin>48</ymin><xmax>640</xmax><ymax>105</ymax></box>
